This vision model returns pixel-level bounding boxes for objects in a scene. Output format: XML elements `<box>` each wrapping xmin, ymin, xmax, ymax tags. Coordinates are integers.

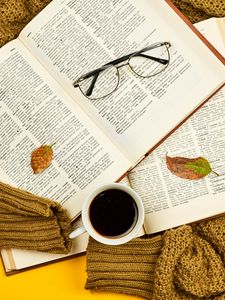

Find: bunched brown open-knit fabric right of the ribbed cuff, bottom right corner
<box><xmin>152</xmin><ymin>225</ymin><xmax>225</xmax><ymax>300</ymax></box>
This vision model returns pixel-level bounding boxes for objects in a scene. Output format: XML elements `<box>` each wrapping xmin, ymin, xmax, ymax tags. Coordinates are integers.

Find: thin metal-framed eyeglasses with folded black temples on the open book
<box><xmin>73</xmin><ymin>42</ymin><xmax>171</xmax><ymax>100</ymax></box>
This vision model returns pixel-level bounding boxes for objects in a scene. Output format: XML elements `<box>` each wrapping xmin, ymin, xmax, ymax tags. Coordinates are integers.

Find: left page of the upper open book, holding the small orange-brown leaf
<box><xmin>0</xmin><ymin>41</ymin><xmax>131</xmax><ymax>218</ymax></box>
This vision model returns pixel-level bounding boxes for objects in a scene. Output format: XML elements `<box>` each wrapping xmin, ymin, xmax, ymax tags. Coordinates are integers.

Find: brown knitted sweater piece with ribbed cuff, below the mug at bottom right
<box><xmin>86</xmin><ymin>216</ymin><xmax>225</xmax><ymax>300</ymax></box>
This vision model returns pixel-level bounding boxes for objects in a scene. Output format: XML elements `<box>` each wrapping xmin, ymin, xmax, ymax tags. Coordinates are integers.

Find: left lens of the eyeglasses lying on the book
<box><xmin>79</xmin><ymin>65</ymin><xmax>119</xmax><ymax>99</ymax></box>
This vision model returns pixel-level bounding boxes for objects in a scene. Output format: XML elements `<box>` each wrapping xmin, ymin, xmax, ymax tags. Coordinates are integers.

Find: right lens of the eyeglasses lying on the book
<box><xmin>129</xmin><ymin>45</ymin><xmax>169</xmax><ymax>77</ymax></box>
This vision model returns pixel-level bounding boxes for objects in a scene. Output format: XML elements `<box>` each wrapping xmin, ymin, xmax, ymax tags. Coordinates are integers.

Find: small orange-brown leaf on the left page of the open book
<box><xmin>31</xmin><ymin>145</ymin><xmax>53</xmax><ymax>174</ymax></box>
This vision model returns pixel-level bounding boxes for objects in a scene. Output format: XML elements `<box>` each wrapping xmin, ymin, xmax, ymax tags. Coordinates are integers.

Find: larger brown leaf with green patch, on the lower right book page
<box><xmin>166</xmin><ymin>156</ymin><xmax>212</xmax><ymax>180</ymax></box>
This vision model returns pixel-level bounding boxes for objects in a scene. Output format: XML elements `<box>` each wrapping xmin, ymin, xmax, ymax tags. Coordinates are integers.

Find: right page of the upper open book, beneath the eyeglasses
<box><xmin>20</xmin><ymin>0</ymin><xmax>224</xmax><ymax>162</ymax></box>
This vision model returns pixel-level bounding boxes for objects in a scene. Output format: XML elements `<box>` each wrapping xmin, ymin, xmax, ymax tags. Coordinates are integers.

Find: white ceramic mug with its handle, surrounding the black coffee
<box><xmin>70</xmin><ymin>183</ymin><xmax>144</xmax><ymax>245</ymax></box>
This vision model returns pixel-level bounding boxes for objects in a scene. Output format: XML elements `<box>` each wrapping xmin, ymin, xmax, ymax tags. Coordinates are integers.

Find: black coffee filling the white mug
<box><xmin>89</xmin><ymin>189</ymin><xmax>137</xmax><ymax>237</ymax></box>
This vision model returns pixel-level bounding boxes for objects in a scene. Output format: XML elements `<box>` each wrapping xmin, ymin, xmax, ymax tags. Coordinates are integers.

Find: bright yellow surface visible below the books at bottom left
<box><xmin>0</xmin><ymin>256</ymin><xmax>140</xmax><ymax>300</ymax></box>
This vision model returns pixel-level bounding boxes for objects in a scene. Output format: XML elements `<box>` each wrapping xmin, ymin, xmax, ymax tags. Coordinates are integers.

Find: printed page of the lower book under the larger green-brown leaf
<box><xmin>129</xmin><ymin>88</ymin><xmax>225</xmax><ymax>233</ymax></box>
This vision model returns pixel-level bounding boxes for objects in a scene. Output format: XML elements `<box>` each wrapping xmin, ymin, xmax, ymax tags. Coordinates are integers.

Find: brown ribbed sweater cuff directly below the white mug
<box><xmin>85</xmin><ymin>235</ymin><xmax>162</xmax><ymax>299</ymax></box>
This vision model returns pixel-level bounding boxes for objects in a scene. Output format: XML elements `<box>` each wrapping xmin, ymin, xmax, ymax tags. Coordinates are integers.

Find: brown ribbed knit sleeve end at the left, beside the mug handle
<box><xmin>0</xmin><ymin>182</ymin><xmax>72</xmax><ymax>254</ymax></box>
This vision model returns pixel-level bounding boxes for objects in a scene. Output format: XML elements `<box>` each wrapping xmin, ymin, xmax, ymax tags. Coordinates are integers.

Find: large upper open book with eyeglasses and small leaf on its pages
<box><xmin>0</xmin><ymin>0</ymin><xmax>224</xmax><ymax>270</ymax></box>
